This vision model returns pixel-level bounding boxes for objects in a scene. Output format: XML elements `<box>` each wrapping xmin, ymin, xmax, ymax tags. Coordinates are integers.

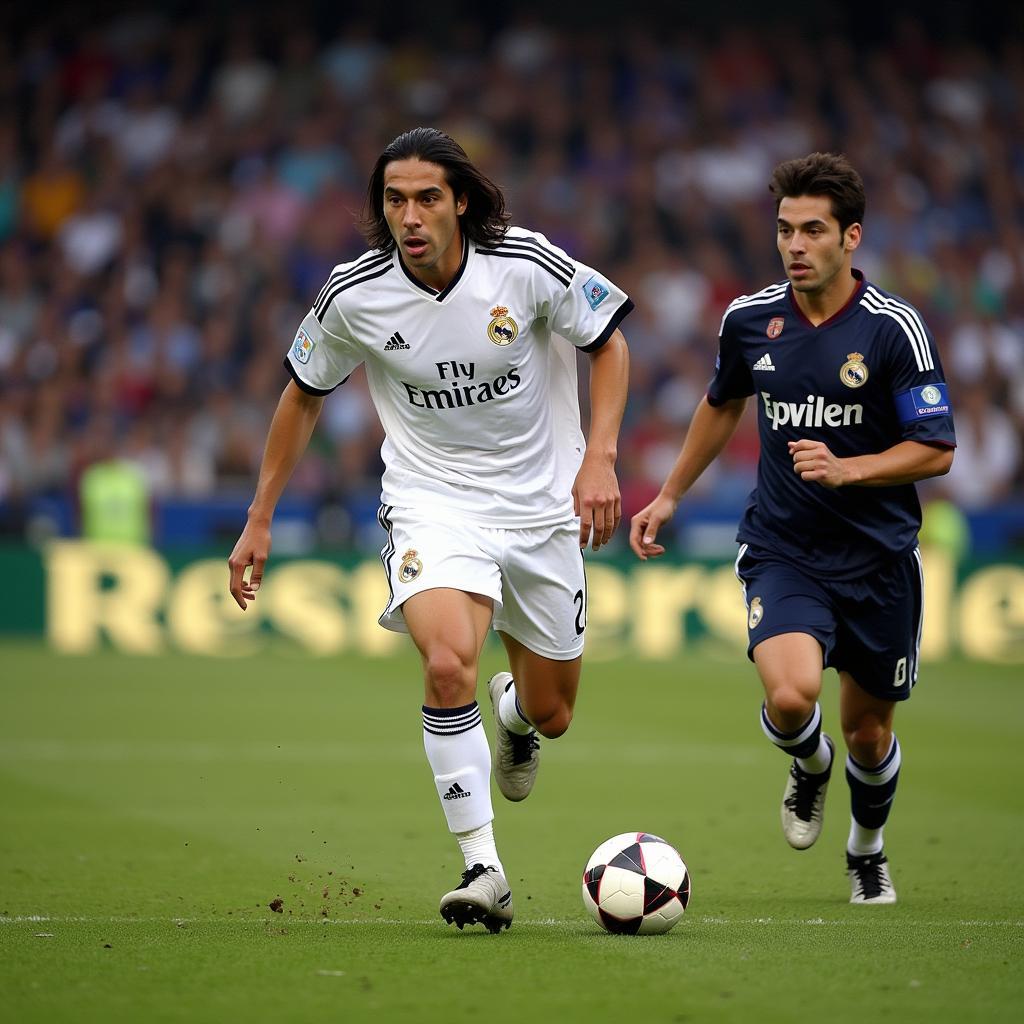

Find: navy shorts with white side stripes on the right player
<box><xmin>736</xmin><ymin>544</ymin><xmax>925</xmax><ymax>700</ymax></box>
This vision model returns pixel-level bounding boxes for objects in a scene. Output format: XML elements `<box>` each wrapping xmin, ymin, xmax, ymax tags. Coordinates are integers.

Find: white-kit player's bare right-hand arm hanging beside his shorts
<box><xmin>572</xmin><ymin>328</ymin><xmax>630</xmax><ymax>551</ymax></box>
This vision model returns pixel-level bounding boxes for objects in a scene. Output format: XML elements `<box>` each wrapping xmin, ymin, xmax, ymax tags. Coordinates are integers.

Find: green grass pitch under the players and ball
<box><xmin>0</xmin><ymin>644</ymin><xmax>1024</xmax><ymax>1024</ymax></box>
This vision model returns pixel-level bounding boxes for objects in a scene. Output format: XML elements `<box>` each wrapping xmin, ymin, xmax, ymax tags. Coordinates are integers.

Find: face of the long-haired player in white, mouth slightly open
<box><xmin>384</xmin><ymin>159</ymin><xmax>466</xmax><ymax>288</ymax></box>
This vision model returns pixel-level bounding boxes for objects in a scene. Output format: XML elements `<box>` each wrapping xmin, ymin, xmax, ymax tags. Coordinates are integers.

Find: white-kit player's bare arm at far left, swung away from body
<box><xmin>227</xmin><ymin>381</ymin><xmax>324</xmax><ymax>611</ymax></box>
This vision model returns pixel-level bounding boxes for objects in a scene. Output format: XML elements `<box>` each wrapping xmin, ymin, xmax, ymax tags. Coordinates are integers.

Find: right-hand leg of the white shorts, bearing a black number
<box><xmin>494</xmin><ymin>521</ymin><xmax>587</xmax><ymax>662</ymax></box>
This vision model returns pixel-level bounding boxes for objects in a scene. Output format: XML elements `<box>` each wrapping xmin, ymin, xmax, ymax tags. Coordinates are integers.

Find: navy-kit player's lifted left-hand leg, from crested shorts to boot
<box><xmin>736</xmin><ymin>546</ymin><xmax>835</xmax><ymax>850</ymax></box>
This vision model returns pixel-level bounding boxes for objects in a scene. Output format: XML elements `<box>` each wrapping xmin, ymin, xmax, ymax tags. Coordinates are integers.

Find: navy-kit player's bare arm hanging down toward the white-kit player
<box><xmin>630</xmin><ymin>395</ymin><xmax>746</xmax><ymax>561</ymax></box>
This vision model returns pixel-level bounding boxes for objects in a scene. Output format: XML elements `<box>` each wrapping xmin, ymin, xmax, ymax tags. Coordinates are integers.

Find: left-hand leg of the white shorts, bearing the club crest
<box><xmin>378</xmin><ymin>506</ymin><xmax>502</xmax><ymax>633</ymax></box>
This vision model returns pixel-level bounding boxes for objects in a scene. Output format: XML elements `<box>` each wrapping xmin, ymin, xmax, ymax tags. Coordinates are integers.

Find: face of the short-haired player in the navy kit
<box><xmin>776</xmin><ymin>196</ymin><xmax>860</xmax><ymax>296</ymax></box>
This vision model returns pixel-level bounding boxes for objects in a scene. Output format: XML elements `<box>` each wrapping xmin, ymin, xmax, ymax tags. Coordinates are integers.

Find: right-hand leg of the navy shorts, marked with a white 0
<box><xmin>830</xmin><ymin>550</ymin><xmax>924</xmax><ymax>701</ymax></box>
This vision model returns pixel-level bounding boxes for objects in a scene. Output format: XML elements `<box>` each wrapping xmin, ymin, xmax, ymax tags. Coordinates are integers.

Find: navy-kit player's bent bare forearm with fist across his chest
<box><xmin>790</xmin><ymin>439</ymin><xmax>953</xmax><ymax>489</ymax></box>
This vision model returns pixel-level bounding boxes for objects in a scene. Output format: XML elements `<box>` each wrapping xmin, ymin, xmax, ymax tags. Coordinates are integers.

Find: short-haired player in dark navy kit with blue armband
<box><xmin>630</xmin><ymin>153</ymin><xmax>956</xmax><ymax>904</ymax></box>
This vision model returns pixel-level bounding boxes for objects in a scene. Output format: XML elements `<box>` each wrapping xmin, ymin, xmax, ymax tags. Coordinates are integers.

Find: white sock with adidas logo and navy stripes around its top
<box><xmin>423</xmin><ymin>700</ymin><xmax>495</xmax><ymax>834</ymax></box>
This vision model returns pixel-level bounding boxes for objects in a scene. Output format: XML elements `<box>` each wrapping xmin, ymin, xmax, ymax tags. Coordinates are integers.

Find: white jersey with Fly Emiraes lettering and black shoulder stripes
<box><xmin>285</xmin><ymin>227</ymin><xmax>633</xmax><ymax>528</ymax></box>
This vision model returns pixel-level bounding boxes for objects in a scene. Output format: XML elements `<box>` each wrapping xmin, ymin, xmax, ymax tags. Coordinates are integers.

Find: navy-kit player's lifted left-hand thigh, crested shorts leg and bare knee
<box><xmin>736</xmin><ymin>545</ymin><xmax>837</xmax><ymax>697</ymax></box>
